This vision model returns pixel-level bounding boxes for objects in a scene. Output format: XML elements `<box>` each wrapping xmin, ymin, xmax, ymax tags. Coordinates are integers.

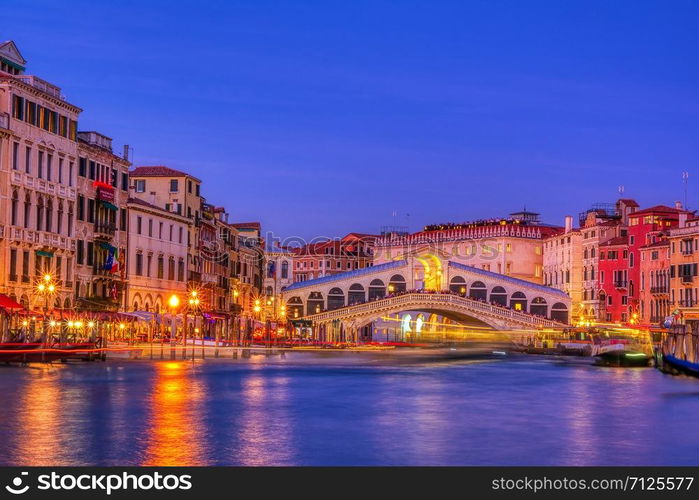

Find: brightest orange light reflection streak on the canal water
<box><xmin>142</xmin><ymin>361</ymin><xmax>206</xmax><ymax>466</ymax></box>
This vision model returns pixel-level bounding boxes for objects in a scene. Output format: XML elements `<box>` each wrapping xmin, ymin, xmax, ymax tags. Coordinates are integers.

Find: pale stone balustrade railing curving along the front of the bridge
<box><xmin>306</xmin><ymin>293</ymin><xmax>562</xmax><ymax>327</ymax></box>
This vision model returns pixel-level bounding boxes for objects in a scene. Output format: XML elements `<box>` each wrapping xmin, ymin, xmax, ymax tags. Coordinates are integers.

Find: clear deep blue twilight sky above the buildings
<box><xmin>0</xmin><ymin>0</ymin><xmax>699</xmax><ymax>238</ymax></box>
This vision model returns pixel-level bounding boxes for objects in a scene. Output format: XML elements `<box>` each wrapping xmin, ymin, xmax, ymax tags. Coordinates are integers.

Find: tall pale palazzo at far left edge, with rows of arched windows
<box><xmin>0</xmin><ymin>41</ymin><xmax>81</xmax><ymax>310</ymax></box>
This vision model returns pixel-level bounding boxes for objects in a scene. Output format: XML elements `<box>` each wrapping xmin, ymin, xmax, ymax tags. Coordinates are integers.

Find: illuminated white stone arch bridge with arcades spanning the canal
<box><xmin>282</xmin><ymin>254</ymin><xmax>571</xmax><ymax>340</ymax></box>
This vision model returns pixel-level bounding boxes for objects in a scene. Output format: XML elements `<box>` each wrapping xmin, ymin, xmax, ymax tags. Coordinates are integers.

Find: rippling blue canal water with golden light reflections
<box><xmin>0</xmin><ymin>353</ymin><xmax>699</xmax><ymax>465</ymax></box>
